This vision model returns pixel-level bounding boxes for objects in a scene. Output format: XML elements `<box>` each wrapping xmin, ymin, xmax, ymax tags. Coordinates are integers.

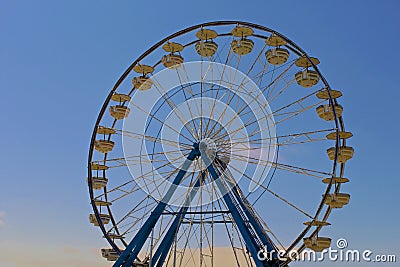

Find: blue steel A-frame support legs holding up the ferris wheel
<box><xmin>113</xmin><ymin>142</ymin><xmax>279</xmax><ymax>267</ymax></box>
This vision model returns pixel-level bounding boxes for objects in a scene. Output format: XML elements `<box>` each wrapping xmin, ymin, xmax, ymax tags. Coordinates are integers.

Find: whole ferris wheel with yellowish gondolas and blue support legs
<box><xmin>88</xmin><ymin>21</ymin><xmax>354</xmax><ymax>267</ymax></box>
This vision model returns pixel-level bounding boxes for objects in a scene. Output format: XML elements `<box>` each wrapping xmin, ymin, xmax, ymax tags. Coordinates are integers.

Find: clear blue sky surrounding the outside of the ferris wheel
<box><xmin>0</xmin><ymin>0</ymin><xmax>400</xmax><ymax>267</ymax></box>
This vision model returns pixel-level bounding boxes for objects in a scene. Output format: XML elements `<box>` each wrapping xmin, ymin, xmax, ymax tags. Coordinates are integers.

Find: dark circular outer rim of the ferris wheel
<box><xmin>87</xmin><ymin>21</ymin><xmax>346</xmax><ymax>264</ymax></box>
